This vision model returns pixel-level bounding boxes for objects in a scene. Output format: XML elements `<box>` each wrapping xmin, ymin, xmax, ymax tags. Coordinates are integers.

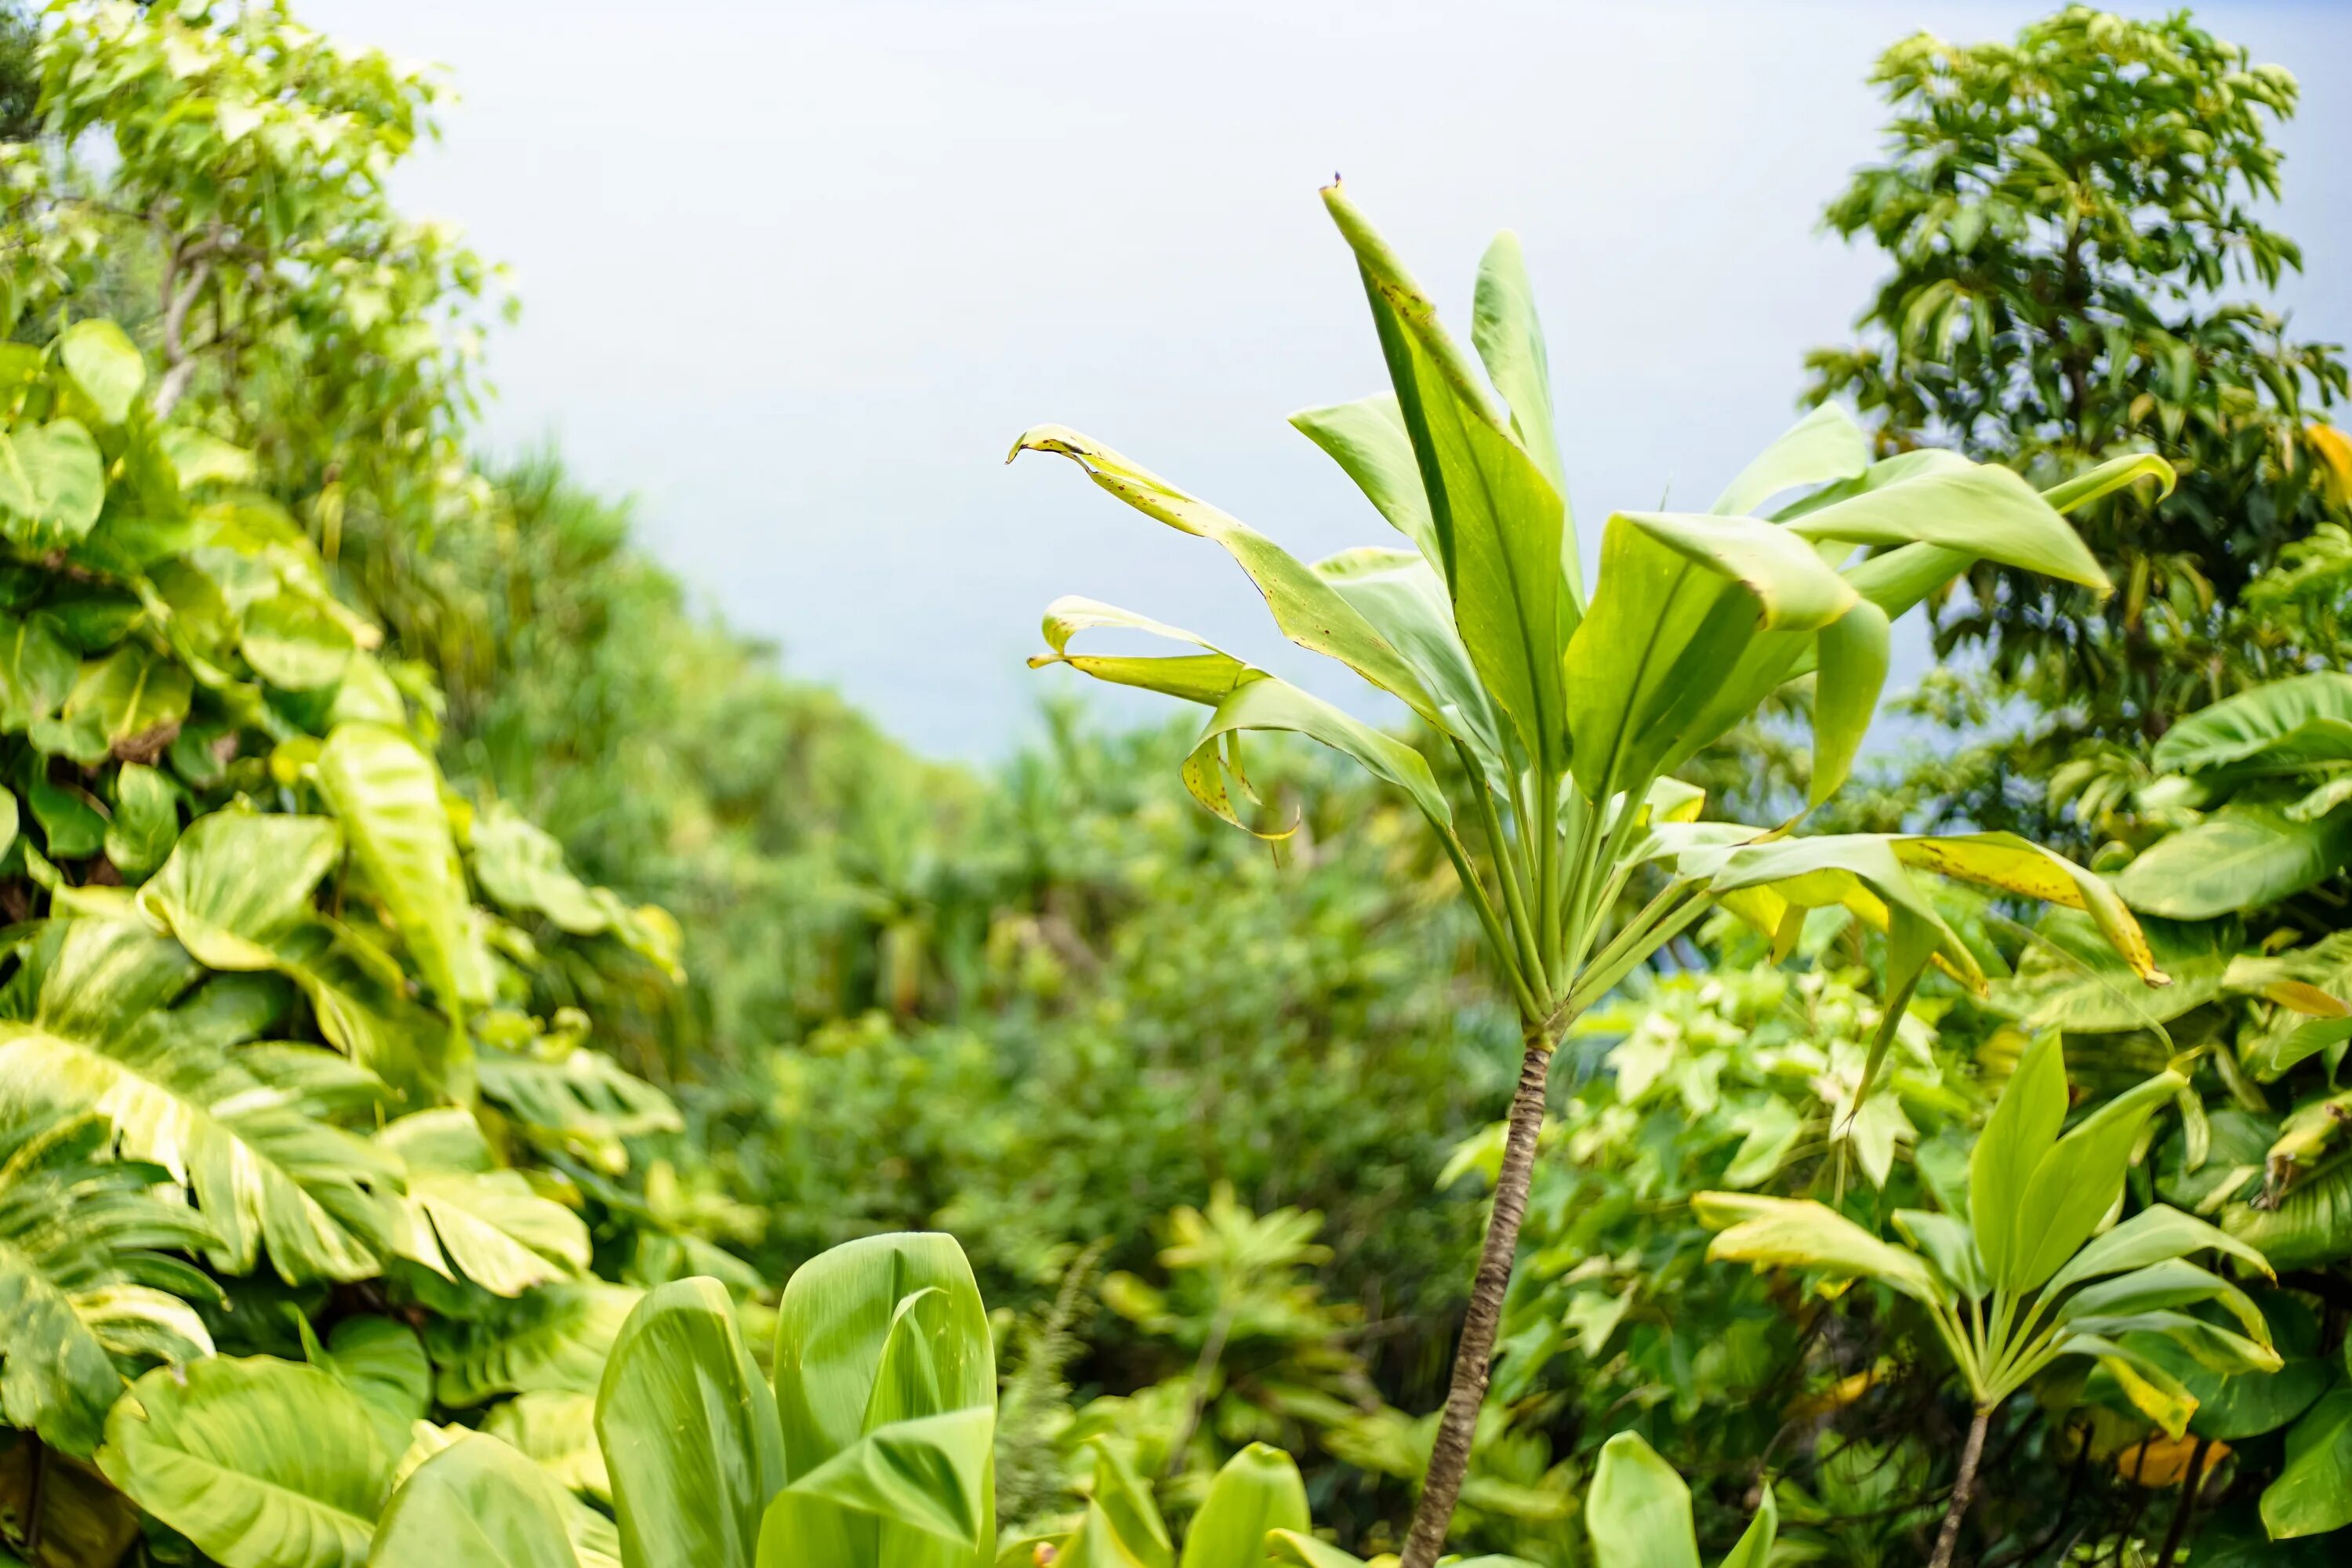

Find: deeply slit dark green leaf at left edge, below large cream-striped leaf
<box><xmin>0</xmin><ymin>1112</ymin><xmax>219</xmax><ymax>1457</ymax></box>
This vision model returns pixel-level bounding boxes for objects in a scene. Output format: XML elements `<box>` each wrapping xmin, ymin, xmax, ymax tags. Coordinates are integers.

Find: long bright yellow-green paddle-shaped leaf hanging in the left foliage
<box><xmin>318</xmin><ymin>724</ymin><xmax>473</xmax><ymax>1098</ymax></box>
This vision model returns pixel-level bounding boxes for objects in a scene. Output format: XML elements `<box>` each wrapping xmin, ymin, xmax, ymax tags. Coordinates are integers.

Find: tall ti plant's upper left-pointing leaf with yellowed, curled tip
<box><xmin>1014</xmin><ymin>426</ymin><xmax>1435</xmax><ymax>720</ymax></box>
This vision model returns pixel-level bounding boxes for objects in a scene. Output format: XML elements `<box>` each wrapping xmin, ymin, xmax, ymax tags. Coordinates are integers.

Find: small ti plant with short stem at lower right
<box><xmin>1691</xmin><ymin>1034</ymin><xmax>2279</xmax><ymax>1568</ymax></box>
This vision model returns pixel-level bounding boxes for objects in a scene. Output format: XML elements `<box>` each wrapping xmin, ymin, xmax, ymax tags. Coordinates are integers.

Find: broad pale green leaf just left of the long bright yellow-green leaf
<box><xmin>139</xmin><ymin>811</ymin><xmax>343</xmax><ymax>971</ymax></box>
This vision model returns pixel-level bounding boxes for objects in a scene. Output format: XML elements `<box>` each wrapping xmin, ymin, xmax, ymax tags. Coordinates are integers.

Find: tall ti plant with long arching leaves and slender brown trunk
<box><xmin>1014</xmin><ymin>186</ymin><xmax>2171</xmax><ymax>1568</ymax></box>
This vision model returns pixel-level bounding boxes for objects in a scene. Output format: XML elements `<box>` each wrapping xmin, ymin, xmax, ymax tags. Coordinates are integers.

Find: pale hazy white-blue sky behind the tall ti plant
<box><xmin>301</xmin><ymin>0</ymin><xmax>2352</xmax><ymax>760</ymax></box>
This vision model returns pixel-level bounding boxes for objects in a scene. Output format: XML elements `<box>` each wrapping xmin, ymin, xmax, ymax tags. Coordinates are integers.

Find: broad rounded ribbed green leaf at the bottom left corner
<box><xmin>99</xmin><ymin>1356</ymin><xmax>393</xmax><ymax>1568</ymax></box>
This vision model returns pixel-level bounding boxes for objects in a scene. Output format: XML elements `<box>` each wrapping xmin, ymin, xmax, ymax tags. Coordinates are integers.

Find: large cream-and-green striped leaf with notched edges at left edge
<box><xmin>0</xmin><ymin>919</ymin><xmax>397</xmax><ymax>1283</ymax></box>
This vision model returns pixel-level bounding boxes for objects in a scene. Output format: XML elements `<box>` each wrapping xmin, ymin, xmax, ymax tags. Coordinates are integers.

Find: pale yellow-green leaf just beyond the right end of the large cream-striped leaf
<box><xmin>376</xmin><ymin>1107</ymin><xmax>588</xmax><ymax>1295</ymax></box>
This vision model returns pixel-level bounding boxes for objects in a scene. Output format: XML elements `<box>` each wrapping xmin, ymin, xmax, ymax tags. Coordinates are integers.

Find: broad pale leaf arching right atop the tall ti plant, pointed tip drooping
<box><xmin>1788</xmin><ymin>454</ymin><xmax>2112</xmax><ymax>593</ymax></box>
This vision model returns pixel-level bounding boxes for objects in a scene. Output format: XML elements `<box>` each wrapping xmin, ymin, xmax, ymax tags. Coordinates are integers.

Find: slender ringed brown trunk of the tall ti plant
<box><xmin>1397</xmin><ymin>1020</ymin><xmax>1562</xmax><ymax>1568</ymax></box>
